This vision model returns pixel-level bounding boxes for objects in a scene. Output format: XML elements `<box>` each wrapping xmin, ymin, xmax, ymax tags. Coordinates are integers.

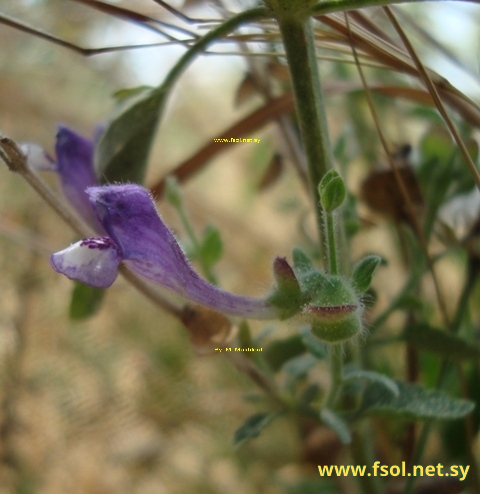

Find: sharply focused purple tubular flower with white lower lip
<box><xmin>51</xmin><ymin>183</ymin><xmax>278</xmax><ymax>319</ymax></box>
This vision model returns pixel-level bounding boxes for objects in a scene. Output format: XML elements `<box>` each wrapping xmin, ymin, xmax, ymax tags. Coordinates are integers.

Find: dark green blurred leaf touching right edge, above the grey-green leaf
<box><xmin>404</xmin><ymin>324</ymin><xmax>480</xmax><ymax>360</ymax></box>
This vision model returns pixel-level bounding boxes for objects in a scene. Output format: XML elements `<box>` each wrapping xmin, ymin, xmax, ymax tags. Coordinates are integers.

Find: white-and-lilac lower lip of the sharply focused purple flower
<box><xmin>50</xmin><ymin>237</ymin><xmax>122</xmax><ymax>288</ymax></box>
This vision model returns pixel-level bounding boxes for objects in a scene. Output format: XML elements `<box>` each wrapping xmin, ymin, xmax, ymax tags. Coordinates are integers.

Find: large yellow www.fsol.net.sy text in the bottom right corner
<box><xmin>318</xmin><ymin>461</ymin><xmax>470</xmax><ymax>481</ymax></box>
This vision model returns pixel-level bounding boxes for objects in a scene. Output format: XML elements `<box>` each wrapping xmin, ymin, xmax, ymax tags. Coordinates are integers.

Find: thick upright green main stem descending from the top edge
<box><xmin>274</xmin><ymin>9</ymin><xmax>333</xmax><ymax>246</ymax></box>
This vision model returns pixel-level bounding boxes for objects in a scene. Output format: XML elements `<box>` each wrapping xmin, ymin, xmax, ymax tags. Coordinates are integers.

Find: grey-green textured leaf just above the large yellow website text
<box><xmin>360</xmin><ymin>381</ymin><xmax>475</xmax><ymax>420</ymax></box>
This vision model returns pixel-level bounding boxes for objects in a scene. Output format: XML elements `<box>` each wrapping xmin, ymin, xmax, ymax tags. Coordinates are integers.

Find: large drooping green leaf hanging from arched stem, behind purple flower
<box><xmin>95</xmin><ymin>86</ymin><xmax>166</xmax><ymax>183</ymax></box>
